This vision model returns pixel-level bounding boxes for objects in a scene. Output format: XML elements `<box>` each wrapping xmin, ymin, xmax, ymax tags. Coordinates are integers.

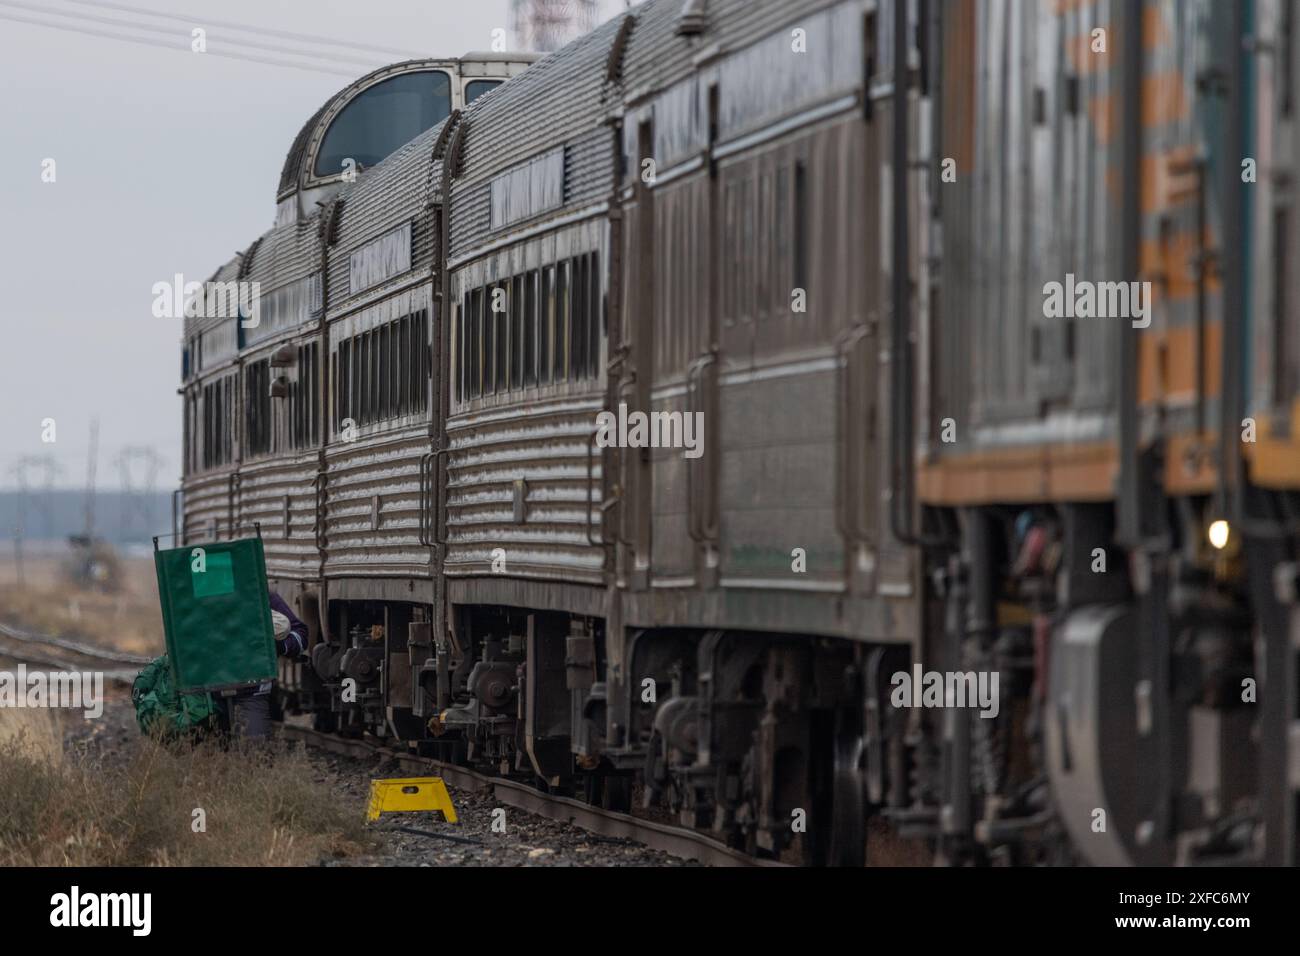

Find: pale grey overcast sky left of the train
<box><xmin>0</xmin><ymin>0</ymin><xmax>623</xmax><ymax>489</ymax></box>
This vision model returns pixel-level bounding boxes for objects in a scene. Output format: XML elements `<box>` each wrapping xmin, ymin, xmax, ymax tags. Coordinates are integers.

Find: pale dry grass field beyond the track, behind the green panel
<box><xmin>0</xmin><ymin>555</ymin><xmax>164</xmax><ymax>654</ymax></box>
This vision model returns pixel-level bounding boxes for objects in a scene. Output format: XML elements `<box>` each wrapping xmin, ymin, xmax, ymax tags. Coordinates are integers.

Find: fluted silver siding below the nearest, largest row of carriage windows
<box><xmin>443</xmin><ymin>397</ymin><xmax>605</xmax><ymax>584</ymax></box>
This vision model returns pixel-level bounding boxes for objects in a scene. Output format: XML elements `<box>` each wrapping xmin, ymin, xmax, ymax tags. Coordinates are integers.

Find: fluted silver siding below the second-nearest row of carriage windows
<box><xmin>325</xmin><ymin>427</ymin><xmax>430</xmax><ymax>578</ymax></box>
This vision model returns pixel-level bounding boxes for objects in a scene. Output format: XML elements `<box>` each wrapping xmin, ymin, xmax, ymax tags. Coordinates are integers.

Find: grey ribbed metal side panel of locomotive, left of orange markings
<box><xmin>932</xmin><ymin>0</ymin><xmax>1122</xmax><ymax>444</ymax></box>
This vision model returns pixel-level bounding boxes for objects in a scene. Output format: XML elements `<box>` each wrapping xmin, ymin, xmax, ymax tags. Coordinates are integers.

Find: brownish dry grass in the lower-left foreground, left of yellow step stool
<box><xmin>0</xmin><ymin>709</ymin><xmax>373</xmax><ymax>866</ymax></box>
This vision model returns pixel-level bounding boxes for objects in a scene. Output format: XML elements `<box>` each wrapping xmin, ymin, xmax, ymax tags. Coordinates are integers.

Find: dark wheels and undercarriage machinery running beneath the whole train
<box><xmin>281</xmin><ymin>489</ymin><xmax>1295</xmax><ymax>865</ymax></box>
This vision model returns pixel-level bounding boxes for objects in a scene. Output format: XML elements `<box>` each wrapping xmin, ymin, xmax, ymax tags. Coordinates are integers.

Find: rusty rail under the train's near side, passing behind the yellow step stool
<box><xmin>282</xmin><ymin>724</ymin><xmax>785</xmax><ymax>866</ymax></box>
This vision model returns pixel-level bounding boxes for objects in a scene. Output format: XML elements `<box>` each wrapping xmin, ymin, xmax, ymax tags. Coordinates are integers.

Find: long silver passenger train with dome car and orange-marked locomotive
<box><xmin>174</xmin><ymin>0</ymin><xmax>1300</xmax><ymax>866</ymax></box>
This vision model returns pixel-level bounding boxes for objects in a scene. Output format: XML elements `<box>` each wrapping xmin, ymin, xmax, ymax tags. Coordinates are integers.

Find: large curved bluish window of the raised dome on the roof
<box><xmin>315</xmin><ymin>70</ymin><xmax>451</xmax><ymax>176</ymax></box>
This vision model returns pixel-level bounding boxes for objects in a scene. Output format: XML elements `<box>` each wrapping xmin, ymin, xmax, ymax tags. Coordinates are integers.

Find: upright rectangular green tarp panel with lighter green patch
<box><xmin>153</xmin><ymin>537</ymin><xmax>276</xmax><ymax>693</ymax></box>
